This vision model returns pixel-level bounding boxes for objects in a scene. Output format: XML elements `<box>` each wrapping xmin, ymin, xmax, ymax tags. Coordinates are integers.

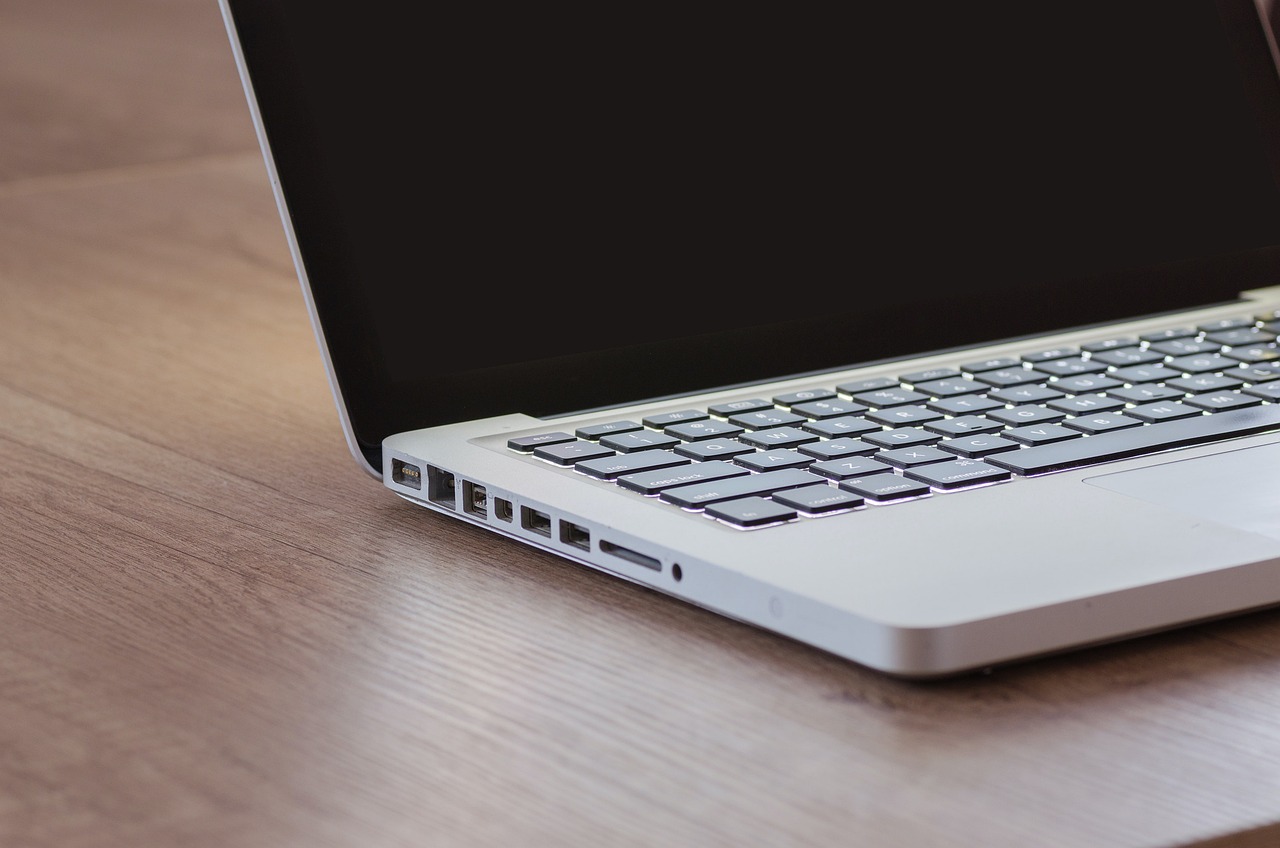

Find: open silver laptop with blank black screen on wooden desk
<box><xmin>221</xmin><ymin>0</ymin><xmax>1280</xmax><ymax>679</ymax></box>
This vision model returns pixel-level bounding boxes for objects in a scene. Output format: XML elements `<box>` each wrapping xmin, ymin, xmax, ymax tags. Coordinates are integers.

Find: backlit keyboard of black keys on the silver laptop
<box><xmin>507</xmin><ymin>310</ymin><xmax>1280</xmax><ymax>529</ymax></box>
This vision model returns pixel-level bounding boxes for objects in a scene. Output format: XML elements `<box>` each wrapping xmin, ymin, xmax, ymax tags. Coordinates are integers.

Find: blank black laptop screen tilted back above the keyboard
<box><xmin>228</xmin><ymin>0</ymin><xmax>1280</xmax><ymax>466</ymax></box>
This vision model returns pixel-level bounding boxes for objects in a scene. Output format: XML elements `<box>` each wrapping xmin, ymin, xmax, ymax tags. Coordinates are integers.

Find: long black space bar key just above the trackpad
<box><xmin>984</xmin><ymin>404</ymin><xmax>1280</xmax><ymax>477</ymax></box>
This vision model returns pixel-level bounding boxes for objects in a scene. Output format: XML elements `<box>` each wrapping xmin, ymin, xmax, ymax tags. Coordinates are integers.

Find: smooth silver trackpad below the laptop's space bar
<box><xmin>1084</xmin><ymin>444</ymin><xmax>1280</xmax><ymax>539</ymax></box>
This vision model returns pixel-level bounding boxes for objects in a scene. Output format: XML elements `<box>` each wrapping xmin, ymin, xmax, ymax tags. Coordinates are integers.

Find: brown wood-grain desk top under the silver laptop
<box><xmin>0</xmin><ymin>0</ymin><xmax>1280</xmax><ymax>848</ymax></box>
